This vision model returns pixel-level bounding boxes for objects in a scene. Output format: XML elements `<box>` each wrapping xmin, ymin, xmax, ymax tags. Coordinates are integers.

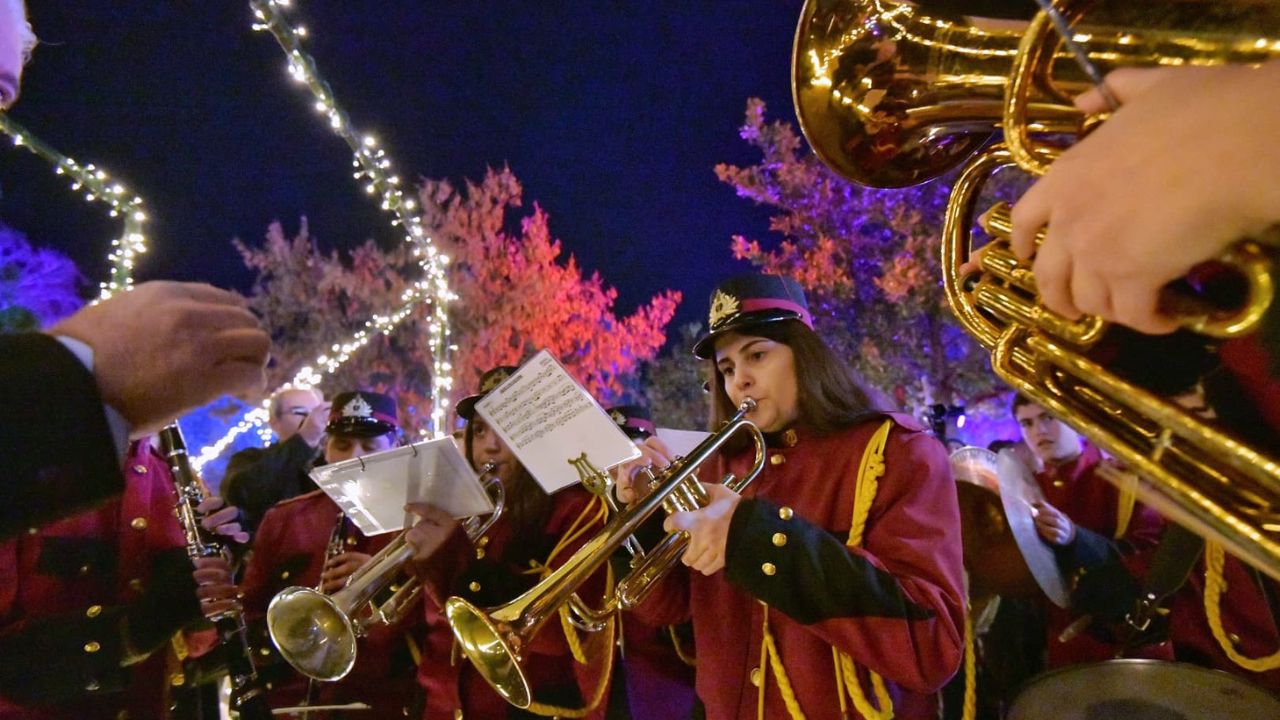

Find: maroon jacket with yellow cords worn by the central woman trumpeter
<box><xmin>637</xmin><ymin>415</ymin><xmax>964</xmax><ymax>720</ymax></box>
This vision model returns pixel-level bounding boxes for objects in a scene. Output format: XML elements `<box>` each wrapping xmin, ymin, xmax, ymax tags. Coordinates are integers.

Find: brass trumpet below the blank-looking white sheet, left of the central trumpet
<box><xmin>266</xmin><ymin>464</ymin><xmax>507</xmax><ymax>682</ymax></box>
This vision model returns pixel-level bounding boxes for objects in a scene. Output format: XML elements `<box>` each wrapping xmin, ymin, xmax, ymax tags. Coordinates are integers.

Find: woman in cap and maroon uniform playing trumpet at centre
<box><xmin>620</xmin><ymin>275</ymin><xmax>964</xmax><ymax>720</ymax></box>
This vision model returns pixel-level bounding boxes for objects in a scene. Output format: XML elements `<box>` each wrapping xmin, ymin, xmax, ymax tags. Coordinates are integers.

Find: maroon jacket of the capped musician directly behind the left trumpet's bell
<box><xmin>242</xmin><ymin>489</ymin><xmax>422</xmax><ymax>719</ymax></box>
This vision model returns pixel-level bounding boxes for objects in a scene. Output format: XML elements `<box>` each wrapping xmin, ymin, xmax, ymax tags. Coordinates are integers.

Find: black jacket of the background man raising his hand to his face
<box><xmin>221</xmin><ymin>436</ymin><xmax>316</xmax><ymax>532</ymax></box>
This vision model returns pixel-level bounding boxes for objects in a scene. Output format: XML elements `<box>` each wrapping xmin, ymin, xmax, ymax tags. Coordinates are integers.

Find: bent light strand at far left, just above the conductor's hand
<box><xmin>0</xmin><ymin>114</ymin><xmax>147</xmax><ymax>300</ymax></box>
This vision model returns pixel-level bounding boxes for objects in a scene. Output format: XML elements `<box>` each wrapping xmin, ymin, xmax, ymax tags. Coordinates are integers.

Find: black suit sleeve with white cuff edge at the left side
<box><xmin>0</xmin><ymin>333</ymin><xmax>124</xmax><ymax>538</ymax></box>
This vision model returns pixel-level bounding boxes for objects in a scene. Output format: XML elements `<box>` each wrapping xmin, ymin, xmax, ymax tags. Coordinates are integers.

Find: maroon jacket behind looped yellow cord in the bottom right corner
<box><xmin>1169</xmin><ymin>555</ymin><xmax>1280</xmax><ymax>693</ymax></box>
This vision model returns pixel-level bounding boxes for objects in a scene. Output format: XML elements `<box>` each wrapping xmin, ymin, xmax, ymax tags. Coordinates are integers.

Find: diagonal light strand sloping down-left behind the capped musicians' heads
<box><xmin>191</xmin><ymin>282</ymin><xmax>433</xmax><ymax>473</ymax></box>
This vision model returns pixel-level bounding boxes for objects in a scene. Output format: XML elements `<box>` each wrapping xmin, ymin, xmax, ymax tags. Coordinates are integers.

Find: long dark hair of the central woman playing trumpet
<box><xmin>710</xmin><ymin>320</ymin><xmax>878</xmax><ymax>434</ymax></box>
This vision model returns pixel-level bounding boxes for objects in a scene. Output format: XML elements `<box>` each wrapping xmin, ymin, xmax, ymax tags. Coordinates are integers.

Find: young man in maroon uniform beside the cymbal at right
<box><xmin>1012</xmin><ymin>396</ymin><xmax>1171</xmax><ymax>669</ymax></box>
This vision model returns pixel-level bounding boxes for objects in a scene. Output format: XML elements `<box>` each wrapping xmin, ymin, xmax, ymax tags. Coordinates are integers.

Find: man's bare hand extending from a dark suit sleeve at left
<box><xmin>49</xmin><ymin>282</ymin><xmax>271</xmax><ymax>437</ymax></box>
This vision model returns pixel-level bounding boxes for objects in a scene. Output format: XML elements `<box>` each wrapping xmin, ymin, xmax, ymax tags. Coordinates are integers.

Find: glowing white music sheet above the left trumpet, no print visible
<box><xmin>311</xmin><ymin>437</ymin><xmax>493</xmax><ymax>536</ymax></box>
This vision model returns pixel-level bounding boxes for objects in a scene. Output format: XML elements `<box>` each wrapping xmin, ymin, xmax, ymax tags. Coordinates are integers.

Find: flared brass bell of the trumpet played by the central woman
<box><xmin>444</xmin><ymin>597</ymin><xmax>534</xmax><ymax>708</ymax></box>
